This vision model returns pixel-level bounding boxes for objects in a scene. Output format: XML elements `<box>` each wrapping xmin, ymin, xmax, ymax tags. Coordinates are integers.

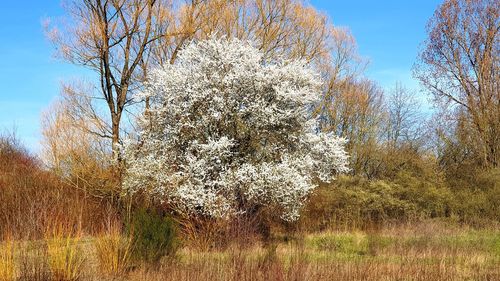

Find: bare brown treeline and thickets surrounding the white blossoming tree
<box><xmin>0</xmin><ymin>0</ymin><xmax>500</xmax><ymax>241</ymax></box>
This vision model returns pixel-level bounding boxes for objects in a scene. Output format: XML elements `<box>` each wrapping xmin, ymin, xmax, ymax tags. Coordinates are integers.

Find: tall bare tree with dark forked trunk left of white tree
<box><xmin>48</xmin><ymin>0</ymin><xmax>170</xmax><ymax>155</ymax></box>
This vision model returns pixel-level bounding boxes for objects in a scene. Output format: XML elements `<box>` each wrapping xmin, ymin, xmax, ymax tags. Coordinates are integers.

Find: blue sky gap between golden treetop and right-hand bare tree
<box><xmin>311</xmin><ymin>0</ymin><xmax>442</xmax><ymax>89</ymax></box>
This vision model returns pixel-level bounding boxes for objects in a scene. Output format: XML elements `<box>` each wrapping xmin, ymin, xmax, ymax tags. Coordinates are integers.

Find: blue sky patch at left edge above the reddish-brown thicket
<box><xmin>0</xmin><ymin>0</ymin><xmax>80</xmax><ymax>152</ymax></box>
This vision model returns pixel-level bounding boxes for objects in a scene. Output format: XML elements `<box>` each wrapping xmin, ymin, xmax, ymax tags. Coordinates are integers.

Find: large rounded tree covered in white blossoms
<box><xmin>124</xmin><ymin>37</ymin><xmax>348</xmax><ymax>220</ymax></box>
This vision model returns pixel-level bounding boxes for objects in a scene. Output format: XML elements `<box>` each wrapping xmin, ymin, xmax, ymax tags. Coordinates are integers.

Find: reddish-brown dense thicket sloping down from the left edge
<box><xmin>0</xmin><ymin>132</ymin><xmax>115</xmax><ymax>239</ymax></box>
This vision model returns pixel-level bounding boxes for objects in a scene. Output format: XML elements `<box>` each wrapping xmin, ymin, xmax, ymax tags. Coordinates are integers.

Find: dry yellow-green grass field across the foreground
<box><xmin>0</xmin><ymin>222</ymin><xmax>500</xmax><ymax>281</ymax></box>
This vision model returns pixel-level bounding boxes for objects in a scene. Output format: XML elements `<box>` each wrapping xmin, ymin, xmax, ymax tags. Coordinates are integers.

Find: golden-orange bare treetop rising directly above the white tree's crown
<box><xmin>152</xmin><ymin>0</ymin><xmax>333</xmax><ymax>64</ymax></box>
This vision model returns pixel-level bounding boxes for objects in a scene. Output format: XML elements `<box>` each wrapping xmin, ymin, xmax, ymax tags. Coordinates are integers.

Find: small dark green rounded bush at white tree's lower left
<box><xmin>128</xmin><ymin>208</ymin><xmax>177</xmax><ymax>264</ymax></box>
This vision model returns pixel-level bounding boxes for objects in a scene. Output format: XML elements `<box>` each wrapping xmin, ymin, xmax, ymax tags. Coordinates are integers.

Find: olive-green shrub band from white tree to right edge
<box><xmin>301</xmin><ymin>170</ymin><xmax>500</xmax><ymax>230</ymax></box>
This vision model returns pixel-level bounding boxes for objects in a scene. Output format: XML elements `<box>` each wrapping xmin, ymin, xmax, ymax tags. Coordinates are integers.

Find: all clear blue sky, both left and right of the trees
<box><xmin>0</xmin><ymin>0</ymin><xmax>441</xmax><ymax>152</ymax></box>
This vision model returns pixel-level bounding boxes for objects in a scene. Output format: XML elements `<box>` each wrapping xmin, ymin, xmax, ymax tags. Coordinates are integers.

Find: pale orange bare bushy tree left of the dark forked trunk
<box><xmin>41</xmin><ymin>92</ymin><xmax>119</xmax><ymax>199</ymax></box>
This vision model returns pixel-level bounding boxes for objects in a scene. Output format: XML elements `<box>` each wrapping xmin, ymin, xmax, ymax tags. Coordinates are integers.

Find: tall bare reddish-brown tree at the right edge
<box><xmin>415</xmin><ymin>0</ymin><xmax>500</xmax><ymax>167</ymax></box>
